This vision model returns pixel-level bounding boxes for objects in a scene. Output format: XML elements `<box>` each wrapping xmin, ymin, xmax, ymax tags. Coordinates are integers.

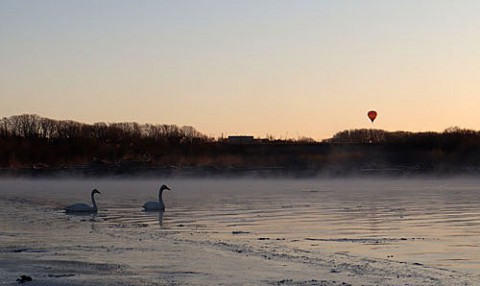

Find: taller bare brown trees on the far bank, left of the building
<box><xmin>0</xmin><ymin>114</ymin><xmax>211</xmax><ymax>168</ymax></box>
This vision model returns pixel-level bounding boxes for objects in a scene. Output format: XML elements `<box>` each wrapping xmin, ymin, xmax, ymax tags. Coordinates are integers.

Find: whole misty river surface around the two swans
<box><xmin>0</xmin><ymin>177</ymin><xmax>480</xmax><ymax>285</ymax></box>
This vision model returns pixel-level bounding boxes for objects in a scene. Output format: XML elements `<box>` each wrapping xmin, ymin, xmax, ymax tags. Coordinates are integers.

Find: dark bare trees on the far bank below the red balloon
<box><xmin>328</xmin><ymin>127</ymin><xmax>480</xmax><ymax>173</ymax></box>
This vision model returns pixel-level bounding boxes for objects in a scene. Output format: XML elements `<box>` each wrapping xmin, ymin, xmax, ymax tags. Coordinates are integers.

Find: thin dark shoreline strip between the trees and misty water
<box><xmin>0</xmin><ymin>164</ymin><xmax>480</xmax><ymax>178</ymax></box>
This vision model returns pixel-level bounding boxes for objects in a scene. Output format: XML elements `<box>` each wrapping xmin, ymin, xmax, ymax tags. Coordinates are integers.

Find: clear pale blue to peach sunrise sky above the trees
<box><xmin>0</xmin><ymin>0</ymin><xmax>480</xmax><ymax>140</ymax></box>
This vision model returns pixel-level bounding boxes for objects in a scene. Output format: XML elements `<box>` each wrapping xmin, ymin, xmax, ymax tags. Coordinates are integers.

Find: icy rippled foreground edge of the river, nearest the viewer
<box><xmin>0</xmin><ymin>230</ymin><xmax>478</xmax><ymax>286</ymax></box>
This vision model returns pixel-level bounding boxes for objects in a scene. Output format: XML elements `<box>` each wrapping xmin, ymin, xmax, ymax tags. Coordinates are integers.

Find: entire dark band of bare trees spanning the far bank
<box><xmin>0</xmin><ymin>114</ymin><xmax>480</xmax><ymax>173</ymax></box>
